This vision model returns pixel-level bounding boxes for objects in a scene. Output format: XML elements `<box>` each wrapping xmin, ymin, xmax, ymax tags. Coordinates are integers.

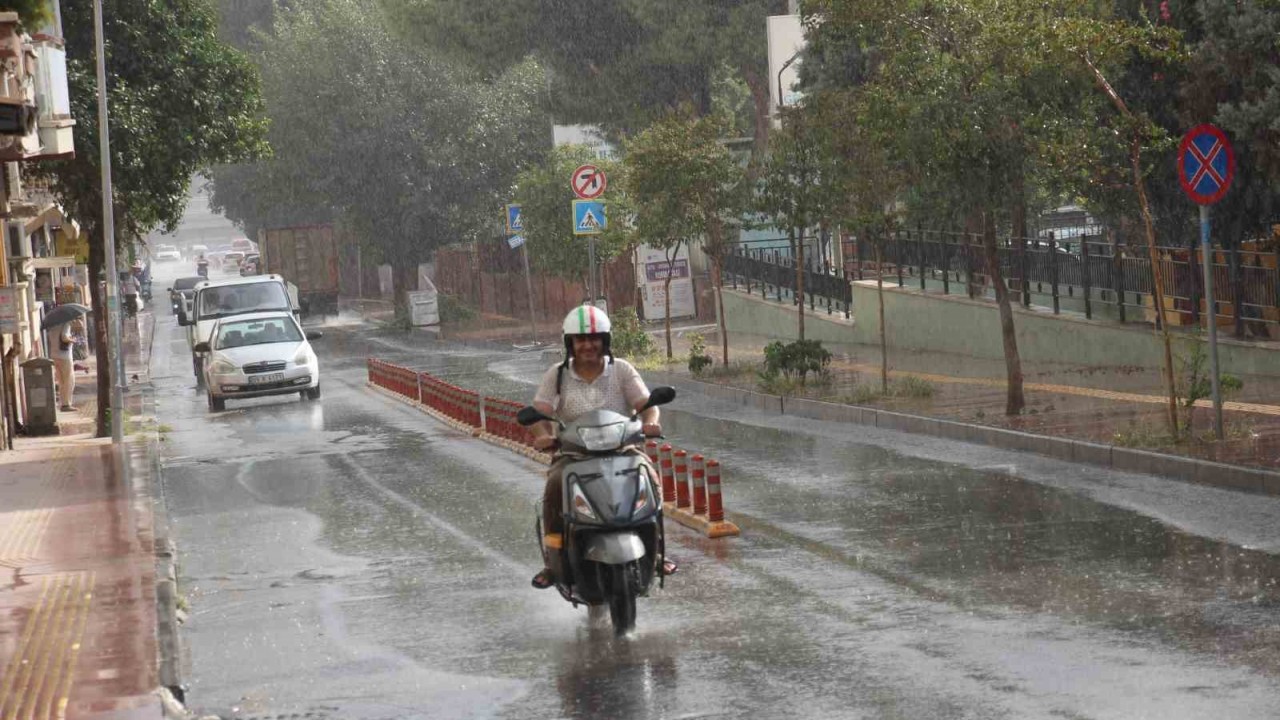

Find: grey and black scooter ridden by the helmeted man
<box><xmin>516</xmin><ymin>387</ymin><xmax>676</xmax><ymax>635</ymax></box>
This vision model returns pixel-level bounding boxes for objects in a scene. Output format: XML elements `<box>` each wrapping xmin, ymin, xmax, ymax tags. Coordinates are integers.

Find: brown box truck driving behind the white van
<box><xmin>257</xmin><ymin>225</ymin><xmax>340</xmax><ymax>315</ymax></box>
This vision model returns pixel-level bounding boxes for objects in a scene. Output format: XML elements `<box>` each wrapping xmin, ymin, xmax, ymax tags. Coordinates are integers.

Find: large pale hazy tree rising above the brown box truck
<box><xmin>214</xmin><ymin>0</ymin><xmax>550</xmax><ymax>302</ymax></box>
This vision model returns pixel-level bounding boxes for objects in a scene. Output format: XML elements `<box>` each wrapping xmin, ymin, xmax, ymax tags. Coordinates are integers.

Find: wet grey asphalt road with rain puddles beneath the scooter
<box><xmin>152</xmin><ymin>271</ymin><xmax>1280</xmax><ymax>720</ymax></box>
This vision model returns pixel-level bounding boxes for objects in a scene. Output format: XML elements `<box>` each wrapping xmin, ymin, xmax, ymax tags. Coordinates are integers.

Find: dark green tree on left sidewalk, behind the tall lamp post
<box><xmin>29</xmin><ymin>0</ymin><xmax>266</xmax><ymax>436</ymax></box>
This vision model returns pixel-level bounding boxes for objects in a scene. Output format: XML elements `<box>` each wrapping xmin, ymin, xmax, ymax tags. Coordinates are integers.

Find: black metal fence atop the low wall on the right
<box><xmin>724</xmin><ymin>229</ymin><xmax>1280</xmax><ymax>340</ymax></box>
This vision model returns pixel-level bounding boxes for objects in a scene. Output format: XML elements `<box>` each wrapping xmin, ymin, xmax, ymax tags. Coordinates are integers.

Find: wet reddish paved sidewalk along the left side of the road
<box><xmin>0</xmin><ymin>315</ymin><xmax>164</xmax><ymax>720</ymax></box>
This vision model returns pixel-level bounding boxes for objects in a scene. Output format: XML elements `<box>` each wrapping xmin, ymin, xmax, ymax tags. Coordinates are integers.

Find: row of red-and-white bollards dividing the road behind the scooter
<box><xmin>367</xmin><ymin>357</ymin><xmax>740</xmax><ymax>538</ymax></box>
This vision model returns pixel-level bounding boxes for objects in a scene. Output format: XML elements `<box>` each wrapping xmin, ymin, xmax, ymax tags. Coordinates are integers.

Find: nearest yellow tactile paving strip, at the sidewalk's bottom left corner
<box><xmin>0</xmin><ymin>573</ymin><xmax>95</xmax><ymax>720</ymax></box>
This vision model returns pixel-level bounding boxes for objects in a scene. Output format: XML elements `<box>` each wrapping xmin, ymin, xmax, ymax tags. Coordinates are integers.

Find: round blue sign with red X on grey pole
<box><xmin>1178</xmin><ymin>124</ymin><xmax>1240</xmax><ymax>439</ymax></box>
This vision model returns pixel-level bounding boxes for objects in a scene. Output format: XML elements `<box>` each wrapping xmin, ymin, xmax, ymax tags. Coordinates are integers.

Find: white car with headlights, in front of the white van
<box><xmin>196</xmin><ymin>313</ymin><xmax>321</xmax><ymax>410</ymax></box>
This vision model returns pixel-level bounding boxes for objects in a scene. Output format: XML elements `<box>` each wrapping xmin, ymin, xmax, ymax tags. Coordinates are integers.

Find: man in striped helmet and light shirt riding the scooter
<box><xmin>531</xmin><ymin>305</ymin><xmax>676</xmax><ymax>589</ymax></box>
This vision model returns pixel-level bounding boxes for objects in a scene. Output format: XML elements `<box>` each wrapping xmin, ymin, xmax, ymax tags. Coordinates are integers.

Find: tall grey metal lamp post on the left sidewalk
<box><xmin>91</xmin><ymin>0</ymin><xmax>124</xmax><ymax>443</ymax></box>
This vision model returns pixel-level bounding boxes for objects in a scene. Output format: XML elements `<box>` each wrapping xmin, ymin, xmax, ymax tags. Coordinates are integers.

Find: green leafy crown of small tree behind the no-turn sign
<box><xmin>509</xmin><ymin>145</ymin><xmax>630</xmax><ymax>281</ymax></box>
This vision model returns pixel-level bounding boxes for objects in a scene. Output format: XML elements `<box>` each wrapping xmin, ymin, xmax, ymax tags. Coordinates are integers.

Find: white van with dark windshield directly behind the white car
<box><xmin>178</xmin><ymin>275</ymin><xmax>298</xmax><ymax>383</ymax></box>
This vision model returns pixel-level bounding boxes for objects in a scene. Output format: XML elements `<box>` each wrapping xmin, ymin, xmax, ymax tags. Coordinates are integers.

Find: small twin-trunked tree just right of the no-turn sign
<box><xmin>623</xmin><ymin>110</ymin><xmax>746</xmax><ymax>365</ymax></box>
